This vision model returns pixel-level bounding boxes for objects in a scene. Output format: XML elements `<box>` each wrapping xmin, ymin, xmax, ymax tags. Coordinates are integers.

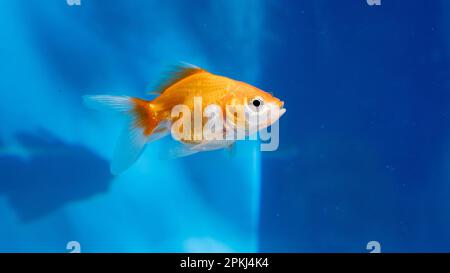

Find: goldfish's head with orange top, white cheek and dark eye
<box><xmin>224</xmin><ymin>82</ymin><xmax>286</xmax><ymax>131</ymax></box>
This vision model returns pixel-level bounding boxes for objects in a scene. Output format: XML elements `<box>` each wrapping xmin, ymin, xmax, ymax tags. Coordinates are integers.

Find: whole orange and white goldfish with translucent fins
<box><xmin>83</xmin><ymin>65</ymin><xmax>286</xmax><ymax>175</ymax></box>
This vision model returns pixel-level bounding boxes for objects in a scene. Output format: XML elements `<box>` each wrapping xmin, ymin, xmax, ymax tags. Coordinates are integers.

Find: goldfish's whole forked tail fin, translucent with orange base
<box><xmin>83</xmin><ymin>95</ymin><xmax>165</xmax><ymax>175</ymax></box>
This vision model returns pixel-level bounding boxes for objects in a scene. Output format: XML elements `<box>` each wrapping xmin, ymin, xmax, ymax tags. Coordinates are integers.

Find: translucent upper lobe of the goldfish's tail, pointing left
<box><xmin>83</xmin><ymin>95</ymin><xmax>133</xmax><ymax>112</ymax></box>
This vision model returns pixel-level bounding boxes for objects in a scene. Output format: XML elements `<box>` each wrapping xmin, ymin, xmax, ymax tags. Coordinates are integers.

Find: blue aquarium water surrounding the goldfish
<box><xmin>0</xmin><ymin>0</ymin><xmax>450</xmax><ymax>252</ymax></box>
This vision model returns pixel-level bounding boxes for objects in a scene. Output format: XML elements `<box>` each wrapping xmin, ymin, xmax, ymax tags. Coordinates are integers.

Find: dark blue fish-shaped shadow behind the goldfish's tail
<box><xmin>0</xmin><ymin>131</ymin><xmax>112</xmax><ymax>222</ymax></box>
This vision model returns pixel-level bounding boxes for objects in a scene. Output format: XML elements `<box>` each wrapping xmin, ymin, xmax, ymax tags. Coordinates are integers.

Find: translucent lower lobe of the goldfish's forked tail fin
<box><xmin>111</xmin><ymin>119</ymin><xmax>149</xmax><ymax>175</ymax></box>
